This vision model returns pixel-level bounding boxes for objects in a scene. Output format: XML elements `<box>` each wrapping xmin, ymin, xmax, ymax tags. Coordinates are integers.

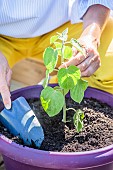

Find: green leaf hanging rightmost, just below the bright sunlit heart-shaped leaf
<box><xmin>70</xmin><ymin>79</ymin><xmax>88</xmax><ymax>103</ymax></box>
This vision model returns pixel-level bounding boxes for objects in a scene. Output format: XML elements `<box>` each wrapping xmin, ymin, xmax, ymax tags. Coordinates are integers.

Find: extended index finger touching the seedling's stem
<box><xmin>59</xmin><ymin>52</ymin><xmax>86</xmax><ymax>69</ymax></box>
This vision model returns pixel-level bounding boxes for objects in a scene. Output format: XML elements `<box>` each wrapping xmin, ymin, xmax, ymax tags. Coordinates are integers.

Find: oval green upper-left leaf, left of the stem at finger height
<box><xmin>43</xmin><ymin>47</ymin><xmax>58</xmax><ymax>73</ymax></box>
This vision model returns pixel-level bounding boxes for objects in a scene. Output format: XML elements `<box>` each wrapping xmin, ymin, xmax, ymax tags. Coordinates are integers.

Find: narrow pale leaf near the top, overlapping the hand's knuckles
<box><xmin>70</xmin><ymin>38</ymin><xmax>85</xmax><ymax>56</ymax></box>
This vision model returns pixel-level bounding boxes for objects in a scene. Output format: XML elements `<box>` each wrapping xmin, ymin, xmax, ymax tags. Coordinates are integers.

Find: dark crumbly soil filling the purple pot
<box><xmin>0</xmin><ymin>98</ymin><xmax>113</xmax><ymax>152</ymax></box>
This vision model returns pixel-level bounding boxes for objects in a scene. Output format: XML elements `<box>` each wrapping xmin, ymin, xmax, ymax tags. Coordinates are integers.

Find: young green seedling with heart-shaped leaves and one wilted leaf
<box><xmin>40</xmin><ymin>28</ymin><xmax>88</xmax><ymax>132</ymax></box>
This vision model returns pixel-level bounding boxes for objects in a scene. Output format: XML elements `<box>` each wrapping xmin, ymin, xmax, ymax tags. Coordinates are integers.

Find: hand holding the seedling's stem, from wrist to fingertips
<box><xmin>60</xmin><ymin>36</ymin><xmax>101</xmax><ymax>77</ymax></box>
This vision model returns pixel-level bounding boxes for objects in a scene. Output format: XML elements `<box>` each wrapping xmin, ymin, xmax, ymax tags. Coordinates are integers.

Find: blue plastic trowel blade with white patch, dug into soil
<box><xmin>0</xmin><ymin>97</ymin><xmax>44</xmax><ymax>148</ymax></box>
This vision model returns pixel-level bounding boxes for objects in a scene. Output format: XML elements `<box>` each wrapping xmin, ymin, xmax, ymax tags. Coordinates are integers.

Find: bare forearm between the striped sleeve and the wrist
<box><xmin>81</xmin><ymin>4</ymin><xmax>110</xmax><ymax>47</ymax></box>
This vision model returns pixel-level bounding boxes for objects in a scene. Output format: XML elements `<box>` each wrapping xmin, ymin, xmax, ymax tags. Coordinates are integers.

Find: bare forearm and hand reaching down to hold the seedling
<box><xmin>60</xmin><ymin>4</ymin><xmax>110</xmax><ymax>77</ymax></box>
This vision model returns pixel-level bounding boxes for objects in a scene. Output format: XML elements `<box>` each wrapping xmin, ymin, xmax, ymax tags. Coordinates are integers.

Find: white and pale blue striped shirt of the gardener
<box><xmin>0</xmin><ymin>0</ymin><xmax>113</xmax><ymax>38</ymax></box>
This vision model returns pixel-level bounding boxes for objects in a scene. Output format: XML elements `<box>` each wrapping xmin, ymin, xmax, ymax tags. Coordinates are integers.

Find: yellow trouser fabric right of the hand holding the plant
<box><xmin>85</xmin><ymin>18</ymin><xmax>113</xmax><ymax>94</ymax></box>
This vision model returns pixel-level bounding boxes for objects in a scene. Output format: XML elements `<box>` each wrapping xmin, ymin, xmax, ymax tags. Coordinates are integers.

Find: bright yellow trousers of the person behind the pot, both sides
<box><xmin>0</xmin><ymin>19</ymin><xmax>113</xmax><ymax>94</ymax></box>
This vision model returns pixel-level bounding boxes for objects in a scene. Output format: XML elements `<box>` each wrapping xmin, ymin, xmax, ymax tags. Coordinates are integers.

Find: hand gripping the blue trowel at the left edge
<box><xmin>0</xmin><ymin>52</ymin><xmax>12</xmax><ymax>109</ymax></box>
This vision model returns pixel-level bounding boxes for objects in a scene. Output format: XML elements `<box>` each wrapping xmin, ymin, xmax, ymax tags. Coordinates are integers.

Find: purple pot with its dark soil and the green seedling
<box><xmin>0</xmin><ymin>29</ymin><xmax>113</xmax><ymax>170</ymax></box>
